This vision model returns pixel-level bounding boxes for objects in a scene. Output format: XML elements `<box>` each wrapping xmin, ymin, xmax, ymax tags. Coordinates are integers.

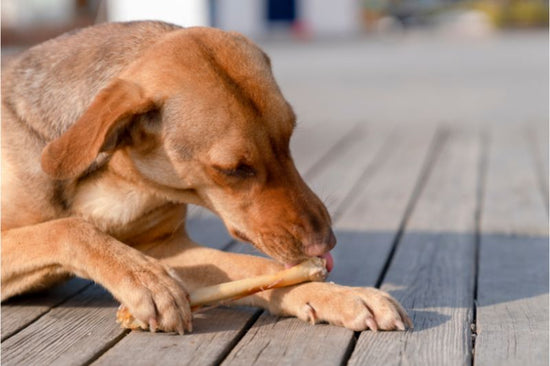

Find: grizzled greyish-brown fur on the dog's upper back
<box><xmin>2</xmin><ymin>22</ymin><xmax>179</xmax><ymax>140</ymax></box>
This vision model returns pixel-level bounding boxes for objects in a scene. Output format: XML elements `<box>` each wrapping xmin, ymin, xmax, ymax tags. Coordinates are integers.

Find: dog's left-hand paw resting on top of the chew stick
<box><xmin>109</xmin><ymin>256</ymin><xmax>192</xmax><ymax>334</ymax></box>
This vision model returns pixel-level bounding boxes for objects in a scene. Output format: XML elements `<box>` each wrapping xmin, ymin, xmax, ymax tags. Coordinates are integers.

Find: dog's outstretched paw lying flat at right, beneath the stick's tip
<box><xmin>269</xmin><ymin>282</ymin><xmax>413</xmax><ymax>331</ymax></box>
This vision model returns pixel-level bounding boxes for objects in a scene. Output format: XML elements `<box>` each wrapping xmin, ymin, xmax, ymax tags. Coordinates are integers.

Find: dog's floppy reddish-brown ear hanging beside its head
<box><xmin>42</xmin><ymin>79</ymin><xmax>155</xmax><ymax>179</ymax></box>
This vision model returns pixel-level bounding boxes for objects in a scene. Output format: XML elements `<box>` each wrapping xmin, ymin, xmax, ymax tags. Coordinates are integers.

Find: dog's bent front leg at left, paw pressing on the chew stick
<box><xmin>2</xmin><ymin>218</ymin><xmax>191</xmax><ymax>333</ymax></box>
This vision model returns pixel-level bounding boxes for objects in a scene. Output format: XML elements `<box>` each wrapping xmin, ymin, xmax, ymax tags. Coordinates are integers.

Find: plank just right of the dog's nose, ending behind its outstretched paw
<box><xmin>330</xmin><ymin>126</ymin><xmax>436</xmax><ymax>286</ymax></box>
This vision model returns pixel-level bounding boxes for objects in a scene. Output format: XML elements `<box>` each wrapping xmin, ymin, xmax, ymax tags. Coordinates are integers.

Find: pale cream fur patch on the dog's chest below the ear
<box><xmin>71</xmin><ymin>176</ymin><xmax>165</xmax><ymax>232</ymax></box>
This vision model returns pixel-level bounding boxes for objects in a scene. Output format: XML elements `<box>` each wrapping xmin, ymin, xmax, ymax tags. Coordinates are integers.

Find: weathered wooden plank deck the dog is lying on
<box><xmin>2</xmin><ymin>123</ymin><xmax>549</xmax><ymax>366</ymax></box>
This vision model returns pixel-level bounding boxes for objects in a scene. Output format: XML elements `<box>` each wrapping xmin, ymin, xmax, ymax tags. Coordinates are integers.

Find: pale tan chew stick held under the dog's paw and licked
<box><xmin>116</xmin><ymin>258</ymin><xmax>328</xmax><ymax>330</ymax></box>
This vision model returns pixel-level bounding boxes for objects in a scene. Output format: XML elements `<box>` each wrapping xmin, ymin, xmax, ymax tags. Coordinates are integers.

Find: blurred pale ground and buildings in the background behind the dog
<box><xmin>1</xmin><ymin>0</ymin><xmax>548</xmax><ymax>125</ymax></box>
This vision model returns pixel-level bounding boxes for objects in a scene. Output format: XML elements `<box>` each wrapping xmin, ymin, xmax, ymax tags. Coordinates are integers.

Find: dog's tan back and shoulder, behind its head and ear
<box><xmin>2</xmin><ymin>22</ymin><xmax>180</xmax><ymax>230</ymax></box>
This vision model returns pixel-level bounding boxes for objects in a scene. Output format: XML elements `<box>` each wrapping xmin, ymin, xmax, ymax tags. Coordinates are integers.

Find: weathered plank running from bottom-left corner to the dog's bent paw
<box><xmin>2</xmin><ymin>286</ymin><xmax>124</xmax><ymax>366</ymax></box>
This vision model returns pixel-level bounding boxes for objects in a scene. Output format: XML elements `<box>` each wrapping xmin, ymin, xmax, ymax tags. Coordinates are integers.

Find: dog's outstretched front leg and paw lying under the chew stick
<box><xmin>149</xmin><ymin>238</ymin><xmax>412</xmax><ymax>331</ymax></box>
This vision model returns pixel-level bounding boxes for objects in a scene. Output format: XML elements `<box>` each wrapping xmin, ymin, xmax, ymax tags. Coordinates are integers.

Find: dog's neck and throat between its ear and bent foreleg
<box><xmin>71</xmin><ymin>151</ymin><xmax>201</xmax><ymax>245</ymax></box>
